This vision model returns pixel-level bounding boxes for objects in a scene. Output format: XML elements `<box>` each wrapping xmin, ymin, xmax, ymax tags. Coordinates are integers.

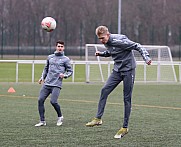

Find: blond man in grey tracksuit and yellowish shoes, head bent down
<box><xmin>86</xmin><ymin>26</ymin><xmax>151</xmax><ymax>139</ymax></box>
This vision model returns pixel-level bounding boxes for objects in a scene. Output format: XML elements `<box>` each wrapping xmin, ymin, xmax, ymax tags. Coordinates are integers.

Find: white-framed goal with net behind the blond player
<box><xmin>85</xmin><ymin>44</ymin><xmax>177</xmax><ymax>82</ymax></box>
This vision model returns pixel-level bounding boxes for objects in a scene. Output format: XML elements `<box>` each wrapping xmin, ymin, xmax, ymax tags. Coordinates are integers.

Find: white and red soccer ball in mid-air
<box><xmin>41</xmin><ymin>17</ymin><xmax>56</xmax><ymax>32</ymax></box>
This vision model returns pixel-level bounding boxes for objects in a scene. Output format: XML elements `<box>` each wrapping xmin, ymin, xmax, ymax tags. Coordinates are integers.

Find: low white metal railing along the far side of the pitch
<box><xmin>0</xmin><ymin>60</ymin><xmax>181</xmax><ymax>83</ymax></box>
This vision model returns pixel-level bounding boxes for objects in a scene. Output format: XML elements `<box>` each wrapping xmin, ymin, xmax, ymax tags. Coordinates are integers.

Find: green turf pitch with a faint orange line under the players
<box><xmin>0</xmin><ymin>83</ymin><xmax>181</xmax><ymax>147</ymax></box>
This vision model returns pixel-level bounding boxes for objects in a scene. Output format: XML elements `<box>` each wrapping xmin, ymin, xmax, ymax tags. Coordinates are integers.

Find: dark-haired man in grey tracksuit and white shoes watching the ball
<box><xmin>35</xmin><ymin>40</ymin><xmax>73</xmax><ymax>127</ymax></box>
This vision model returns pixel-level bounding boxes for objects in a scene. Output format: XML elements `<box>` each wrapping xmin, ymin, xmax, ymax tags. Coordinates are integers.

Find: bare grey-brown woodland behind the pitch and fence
<box><xmin>0</xmin><ymin>0</ymin><xmax>181</xmax><ymax>46</ymax></box>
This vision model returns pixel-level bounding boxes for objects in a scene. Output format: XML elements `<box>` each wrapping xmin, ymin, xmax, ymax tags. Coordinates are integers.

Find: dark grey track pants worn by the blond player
<box><xmin>96</xmin><ymin>69</ymin><xmax>135</xmax><ymax>128</ymax></box>
